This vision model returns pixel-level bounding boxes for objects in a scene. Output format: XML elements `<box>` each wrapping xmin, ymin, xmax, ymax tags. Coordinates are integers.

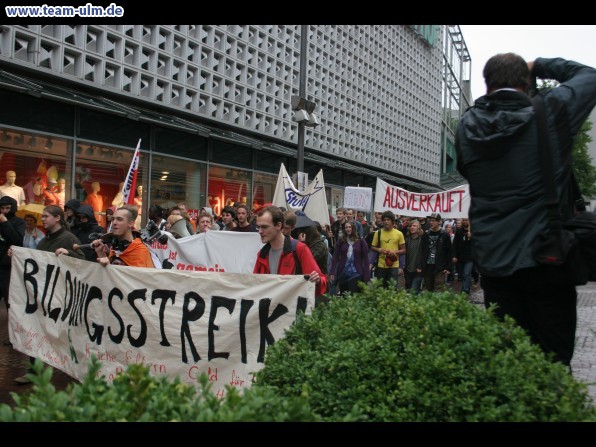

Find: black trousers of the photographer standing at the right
<box><xmin>480</xmin><ymin>267</ymin><xmax>577</xmax><ymax>366</ymax></box>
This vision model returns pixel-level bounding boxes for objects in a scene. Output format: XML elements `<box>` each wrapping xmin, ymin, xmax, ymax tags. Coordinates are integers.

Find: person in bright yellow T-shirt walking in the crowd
<box><xmin>371</xmin><ymin>211</ymin><xmax>406</xmax><ymax>288</ymax></box>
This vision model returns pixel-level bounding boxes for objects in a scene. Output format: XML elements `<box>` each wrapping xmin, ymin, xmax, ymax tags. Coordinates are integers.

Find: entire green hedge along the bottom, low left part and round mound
<box><xmin>0</xmin><ymin>284</ymin><xmax>596</xmax><ymax>422</ymax></box>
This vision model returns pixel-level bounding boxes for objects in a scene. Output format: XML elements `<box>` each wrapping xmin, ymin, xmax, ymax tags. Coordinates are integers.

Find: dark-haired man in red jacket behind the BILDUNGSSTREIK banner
<box><xmin>253</xmin><ymin>206</ymin><xmax>327</xmax><ymax>296</ymax></box>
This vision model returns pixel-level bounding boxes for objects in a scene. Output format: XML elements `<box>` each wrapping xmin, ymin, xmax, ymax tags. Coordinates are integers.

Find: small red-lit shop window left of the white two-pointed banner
<box><xmin>207</xmin><ymin>166</ymin><xmax>252</xmax><ymax>220</ymax></box>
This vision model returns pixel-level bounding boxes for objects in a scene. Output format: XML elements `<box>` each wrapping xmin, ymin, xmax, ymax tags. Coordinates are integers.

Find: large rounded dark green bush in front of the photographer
<box><xmin>257</xmin><ymin>284</ymin><xmax>596</xmax><ymax>422</ymax></box>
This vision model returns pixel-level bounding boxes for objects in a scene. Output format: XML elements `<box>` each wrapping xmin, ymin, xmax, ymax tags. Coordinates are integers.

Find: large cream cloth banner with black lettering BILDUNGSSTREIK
<box><xmin>9</xmin><ymin>247</ymin><xmax>315</xmax><ymax>396</ymax></box>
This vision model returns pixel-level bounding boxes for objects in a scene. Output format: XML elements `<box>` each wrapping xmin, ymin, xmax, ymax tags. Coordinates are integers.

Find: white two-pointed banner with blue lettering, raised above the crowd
<box><xmin>271</xmin><ymin>163</ymin><xmax>330</xmax><ymax>226</ymax></box>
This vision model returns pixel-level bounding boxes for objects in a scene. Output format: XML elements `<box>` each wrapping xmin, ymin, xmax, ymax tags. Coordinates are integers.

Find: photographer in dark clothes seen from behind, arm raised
<box><xmin>455</xmin><ymin>53</ymin><xmax>596</xmax><ymax>366</ymax></box>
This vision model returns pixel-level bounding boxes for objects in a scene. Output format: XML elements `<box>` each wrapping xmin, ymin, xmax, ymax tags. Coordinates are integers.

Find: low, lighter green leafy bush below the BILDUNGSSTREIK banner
<box><xmin>0</xmin><ymin>359</ymin><xmax>319</xmax><ymax>422</ymax></box>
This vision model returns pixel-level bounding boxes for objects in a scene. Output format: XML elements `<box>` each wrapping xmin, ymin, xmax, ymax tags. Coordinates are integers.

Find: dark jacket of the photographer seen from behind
<box><xmin>455</xmin><ymin>58</ymin><xmax>596</xmax><ymax>277</ymax></box>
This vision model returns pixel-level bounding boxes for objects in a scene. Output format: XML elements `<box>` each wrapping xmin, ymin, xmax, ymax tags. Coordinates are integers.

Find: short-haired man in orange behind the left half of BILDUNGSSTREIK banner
<box><xmin>91</xmin><ymin>208</ymin><xmax>155</xmax><ymax>268</ymax></box>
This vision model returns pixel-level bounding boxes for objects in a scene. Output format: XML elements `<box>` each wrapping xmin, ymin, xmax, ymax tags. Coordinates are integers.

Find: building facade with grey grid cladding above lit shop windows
<box><xmin>0</xmin><ymin>25</ymin><xmax>460</xmax><ymax>223</ymax></box>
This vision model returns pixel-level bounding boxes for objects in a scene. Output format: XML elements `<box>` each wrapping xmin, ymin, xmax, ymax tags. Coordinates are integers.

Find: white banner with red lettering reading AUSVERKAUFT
<box><xmin>374</xmin><ymin>178</ymin><xmax>470</xmax><ymax>218</ymax></box>
